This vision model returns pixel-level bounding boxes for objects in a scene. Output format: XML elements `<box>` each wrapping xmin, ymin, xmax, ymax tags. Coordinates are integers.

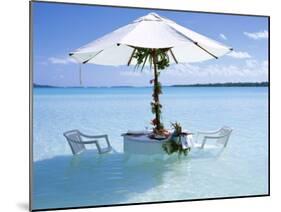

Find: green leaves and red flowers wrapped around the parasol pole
<box><xmin>133</xmin><ymin>48</ymin><xmax>169</xmax><ymax>135</ymax></box>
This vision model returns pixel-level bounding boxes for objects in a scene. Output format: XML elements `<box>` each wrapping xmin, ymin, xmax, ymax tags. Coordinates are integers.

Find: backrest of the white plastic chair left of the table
<box><xmin>63</xmin><ymin>130</ymin><xmax>86</xmax><ymax>155</ymax></box>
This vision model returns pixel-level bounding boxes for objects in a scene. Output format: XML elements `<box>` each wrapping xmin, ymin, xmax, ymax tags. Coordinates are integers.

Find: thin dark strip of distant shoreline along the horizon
<box><xmin>33</xmin><ymin>82</ymin><xmax>269</xmax><ymax>88</ymax></box>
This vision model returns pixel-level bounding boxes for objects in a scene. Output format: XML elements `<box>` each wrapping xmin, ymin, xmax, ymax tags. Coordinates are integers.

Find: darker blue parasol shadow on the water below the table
<box><xmin>33</xmin><ymin>151</ymin><xmax>225</xmax><ymax>208</ymax></box>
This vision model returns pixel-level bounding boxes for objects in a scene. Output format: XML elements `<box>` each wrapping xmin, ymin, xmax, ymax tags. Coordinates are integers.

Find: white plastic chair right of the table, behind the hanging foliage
<box><xmin>196</xmin><ymin>126</ymin><xmax>233</xmax><ymax>149</ymax></box>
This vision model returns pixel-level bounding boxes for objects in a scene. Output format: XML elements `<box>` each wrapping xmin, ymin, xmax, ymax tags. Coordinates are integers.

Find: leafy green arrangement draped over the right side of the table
<box><xmin>162</xmin><ymin>122</ymin><xmax>190</xmax><ymax>156</ymax></box>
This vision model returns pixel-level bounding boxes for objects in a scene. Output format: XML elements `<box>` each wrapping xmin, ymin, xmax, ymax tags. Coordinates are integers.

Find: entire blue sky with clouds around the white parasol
<box><xmin>33</xmin><ymin>2</ymin><xmax>268</xmax><ymax>86</ymax></box>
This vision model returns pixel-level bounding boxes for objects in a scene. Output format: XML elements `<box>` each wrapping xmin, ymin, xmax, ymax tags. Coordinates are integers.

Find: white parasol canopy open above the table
<box><xmin>69</xmin><ymin>13</ymin><xmax>232</xmax><ymax>66</ymax></box>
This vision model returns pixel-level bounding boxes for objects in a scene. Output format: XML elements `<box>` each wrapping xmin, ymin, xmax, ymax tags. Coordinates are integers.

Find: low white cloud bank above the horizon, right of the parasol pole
<box><xmin>161</xmin><ymin>60</ymin><xmax>268</xmax><ymax>85</ymax></box>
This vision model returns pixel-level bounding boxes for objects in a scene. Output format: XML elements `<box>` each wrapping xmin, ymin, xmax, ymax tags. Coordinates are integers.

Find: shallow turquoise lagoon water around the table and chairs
<box><xmin>33</xmin><ymin>87</ymin><xmax>268</xmax><ymax>209</ymax></box>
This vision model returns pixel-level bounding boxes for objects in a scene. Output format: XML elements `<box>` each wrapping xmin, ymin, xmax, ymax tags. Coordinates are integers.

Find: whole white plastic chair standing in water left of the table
<box><xmin>63</xmin><ymin>130</ymin><xmax>112</xmax><ymax>155</ymax></box>
